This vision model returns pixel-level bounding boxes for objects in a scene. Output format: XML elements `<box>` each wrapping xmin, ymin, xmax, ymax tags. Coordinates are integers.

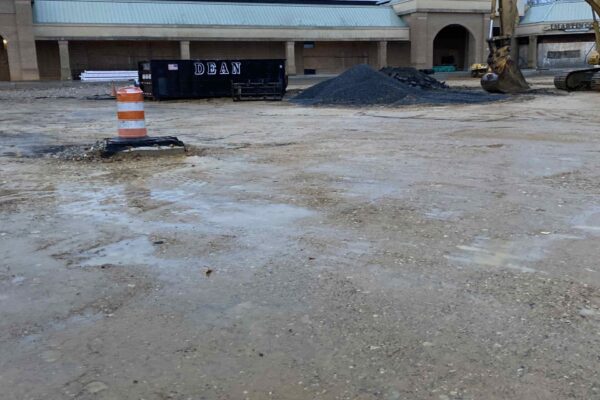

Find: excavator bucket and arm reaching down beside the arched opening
<box><xmin>481</xmin><ymin>0</ymin><xmax>528</xmax><ymax>93</ymax></box>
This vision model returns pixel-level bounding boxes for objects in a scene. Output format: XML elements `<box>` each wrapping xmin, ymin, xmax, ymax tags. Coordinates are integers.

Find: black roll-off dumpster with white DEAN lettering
<box><xmin>138</xmin><ymin>60</ymin><xmax>287</xmax><ymax>100</ymax></box>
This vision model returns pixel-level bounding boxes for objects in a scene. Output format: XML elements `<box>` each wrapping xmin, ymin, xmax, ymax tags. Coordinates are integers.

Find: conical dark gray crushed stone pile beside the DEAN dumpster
<box><xmin>291</xmin><ymin>64</ymin><xmax>505</xmax><ymax>107</ymax></box>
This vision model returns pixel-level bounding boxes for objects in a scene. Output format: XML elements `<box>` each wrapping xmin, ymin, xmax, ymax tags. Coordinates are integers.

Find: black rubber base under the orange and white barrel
<box><xmin>101</xmin><ymin>136</ymin><xmax>185</xmax><ymax>157</ymax></box>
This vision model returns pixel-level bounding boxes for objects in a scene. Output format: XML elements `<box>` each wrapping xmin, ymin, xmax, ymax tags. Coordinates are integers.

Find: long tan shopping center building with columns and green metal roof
<box><xmin>0</xmin><ymin>0</ymin><xmax>591</xmax><ymax>81</ymax></box>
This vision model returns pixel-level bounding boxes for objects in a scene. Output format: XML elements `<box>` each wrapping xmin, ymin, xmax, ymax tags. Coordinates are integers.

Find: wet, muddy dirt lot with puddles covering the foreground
<box><xmin>0</xmin><ymin>78</ymin><xmax>600</xmax><ymax>400</ymax></box>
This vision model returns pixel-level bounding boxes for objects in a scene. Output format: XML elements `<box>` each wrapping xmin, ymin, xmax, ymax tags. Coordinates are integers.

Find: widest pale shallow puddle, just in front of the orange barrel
<box><xmin>58</xmin><ymin>182</ymin><xmax>313</xmax><ymax>232</ymax></box>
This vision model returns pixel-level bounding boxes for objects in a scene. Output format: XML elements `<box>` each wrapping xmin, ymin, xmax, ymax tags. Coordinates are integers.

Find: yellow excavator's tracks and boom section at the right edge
<box><xmin>554</xmin><ymin>0</ymin><xmax>600</xmax><ymax>92</ymax></box>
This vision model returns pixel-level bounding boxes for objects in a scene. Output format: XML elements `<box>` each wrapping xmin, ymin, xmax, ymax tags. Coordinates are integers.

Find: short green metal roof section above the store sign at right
<box><xmin>521</xmin><ymin>0</ymin><xmax>592</xmax><ymax>24</ymax></box>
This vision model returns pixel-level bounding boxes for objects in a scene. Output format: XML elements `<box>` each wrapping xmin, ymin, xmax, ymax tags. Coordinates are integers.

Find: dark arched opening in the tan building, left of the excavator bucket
<box><xmin>433</xmin><ymin>25</ymin><xmax>475</xmax><ymax>71</ymax></box>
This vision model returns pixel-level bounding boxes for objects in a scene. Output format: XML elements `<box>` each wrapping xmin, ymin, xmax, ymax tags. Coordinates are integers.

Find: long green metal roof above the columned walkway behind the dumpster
<box><xmin>33</xmin><ymin>0</ymin><xmax>406</xmax><ymax>28</ymax></box>
